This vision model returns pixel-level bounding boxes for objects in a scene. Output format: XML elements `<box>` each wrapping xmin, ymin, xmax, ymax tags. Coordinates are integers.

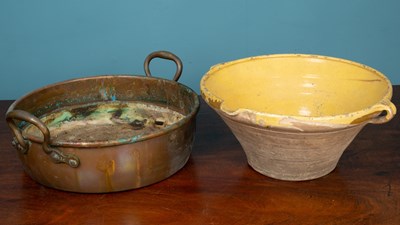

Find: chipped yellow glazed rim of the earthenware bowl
<box><xmin>200</xmin><ymin>54</ymin><xmax>396</xmax><ymax>129</ymax></box>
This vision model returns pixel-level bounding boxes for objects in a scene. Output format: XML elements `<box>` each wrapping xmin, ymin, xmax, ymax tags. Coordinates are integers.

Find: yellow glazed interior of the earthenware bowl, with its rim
<box><xmin>200</xmin><ymin>54</ymin><xmax>396</xmax><ymax>128</ymax></box>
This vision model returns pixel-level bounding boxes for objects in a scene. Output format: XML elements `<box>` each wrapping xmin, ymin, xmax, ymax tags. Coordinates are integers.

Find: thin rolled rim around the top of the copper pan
<box><xmin>6</xmin><ymin>74</ymin><xmax>200</xmax><ymax>148</ymax></box>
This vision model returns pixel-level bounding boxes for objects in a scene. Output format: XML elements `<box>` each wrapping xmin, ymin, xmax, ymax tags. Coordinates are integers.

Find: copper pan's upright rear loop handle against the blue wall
<box><xmin>144</xmin><ymin>51</ymin><xmax>183</xmax><ymax>81</ymax></box>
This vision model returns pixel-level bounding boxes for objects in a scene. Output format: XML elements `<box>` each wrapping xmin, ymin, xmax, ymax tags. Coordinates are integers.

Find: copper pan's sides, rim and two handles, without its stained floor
<box><xmin>6</xmin><ymin>51</ymin><xmax>199</xmax><ymax>193</ymax></box>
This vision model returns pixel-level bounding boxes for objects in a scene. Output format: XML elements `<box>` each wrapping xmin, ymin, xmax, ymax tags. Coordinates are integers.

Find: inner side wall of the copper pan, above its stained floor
<box><xmin>9</xmin><ymin>75</ymin><xmax>199</xmax><ymax>147</ymax></box>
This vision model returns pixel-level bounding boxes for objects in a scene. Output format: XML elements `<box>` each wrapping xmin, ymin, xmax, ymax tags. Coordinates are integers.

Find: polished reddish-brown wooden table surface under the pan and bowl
<box><xmin>0</xmin><ymin>86</ymin><xmax>400</xmax><ymax>225</ymax></box>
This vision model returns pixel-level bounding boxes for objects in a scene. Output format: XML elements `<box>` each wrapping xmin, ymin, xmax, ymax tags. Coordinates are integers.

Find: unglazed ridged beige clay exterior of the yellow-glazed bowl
<box><xmin>220</xmin><ymin>112</ymin><xmax>364</xmax><ymax>181</ymax></box>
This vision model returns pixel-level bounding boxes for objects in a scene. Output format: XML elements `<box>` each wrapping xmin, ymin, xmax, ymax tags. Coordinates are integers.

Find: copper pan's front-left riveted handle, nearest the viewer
<box><xmin>6</xmin><ymin>110</ymin><xmax>80</xmax><ymax>168</ymax></box>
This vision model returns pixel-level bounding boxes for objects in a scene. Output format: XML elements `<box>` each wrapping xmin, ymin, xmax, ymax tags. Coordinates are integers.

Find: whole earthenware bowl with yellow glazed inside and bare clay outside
<box><xmin>200</xmin><ymin>54</ymin><xmax>396</xmax><ymax>181</ymax></box>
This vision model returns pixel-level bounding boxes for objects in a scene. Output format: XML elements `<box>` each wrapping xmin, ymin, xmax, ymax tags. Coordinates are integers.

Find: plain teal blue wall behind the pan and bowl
<box><xmin>0</xmin><ymin>0</ymin><xmax>400</xmax><ymax>99</ymax></box>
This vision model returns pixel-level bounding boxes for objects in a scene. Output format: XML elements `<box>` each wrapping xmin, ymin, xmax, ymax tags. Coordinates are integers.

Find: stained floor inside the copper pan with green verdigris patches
<box><xmin>24</xmin><ymin>101</ymin><xmax>184</xmax><ymax>142</ymax></box>
